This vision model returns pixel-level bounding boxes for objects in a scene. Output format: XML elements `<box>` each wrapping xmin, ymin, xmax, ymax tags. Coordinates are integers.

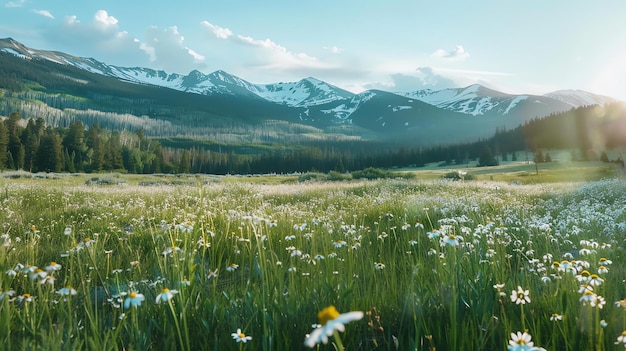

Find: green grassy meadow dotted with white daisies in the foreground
<box><xmin>0</xmin><ymin>167</ymin><xmax>626</xmax><ymax>350</ymax></box>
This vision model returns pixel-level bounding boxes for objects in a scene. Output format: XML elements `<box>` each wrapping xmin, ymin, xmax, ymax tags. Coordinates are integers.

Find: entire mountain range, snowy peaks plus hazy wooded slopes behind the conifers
<box><xmin>0</xmin><ymin>38</ymin><xmax>615</xmax><ymax>145</ymax></box>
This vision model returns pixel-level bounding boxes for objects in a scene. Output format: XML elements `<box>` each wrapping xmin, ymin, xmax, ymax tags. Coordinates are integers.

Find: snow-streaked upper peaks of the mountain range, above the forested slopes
<box><xmin>0</xmin><ymin>38</ymin><xmax>617</xmax><ymax>120</ymax></box>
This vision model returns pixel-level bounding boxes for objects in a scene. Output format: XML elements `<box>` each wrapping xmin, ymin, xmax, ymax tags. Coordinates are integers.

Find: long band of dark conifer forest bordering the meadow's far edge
<box><xmin>0</xmin><ymin>103</ymin><xmax>626</xmax><ymax>174</ymax></box>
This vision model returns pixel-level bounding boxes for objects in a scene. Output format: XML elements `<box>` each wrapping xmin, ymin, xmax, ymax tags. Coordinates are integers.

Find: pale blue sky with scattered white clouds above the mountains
<box><xmin>0</xmin><ymin>0</ymin><xmax>626</xmax><ymax>100</ymax></box>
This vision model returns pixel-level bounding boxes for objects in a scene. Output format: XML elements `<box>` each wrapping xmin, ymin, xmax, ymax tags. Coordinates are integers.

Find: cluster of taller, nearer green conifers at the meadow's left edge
<box><xmin>0</xmin><ymin>112</ymin><xmax>171</xmax><ymax>173</ymax></box>
